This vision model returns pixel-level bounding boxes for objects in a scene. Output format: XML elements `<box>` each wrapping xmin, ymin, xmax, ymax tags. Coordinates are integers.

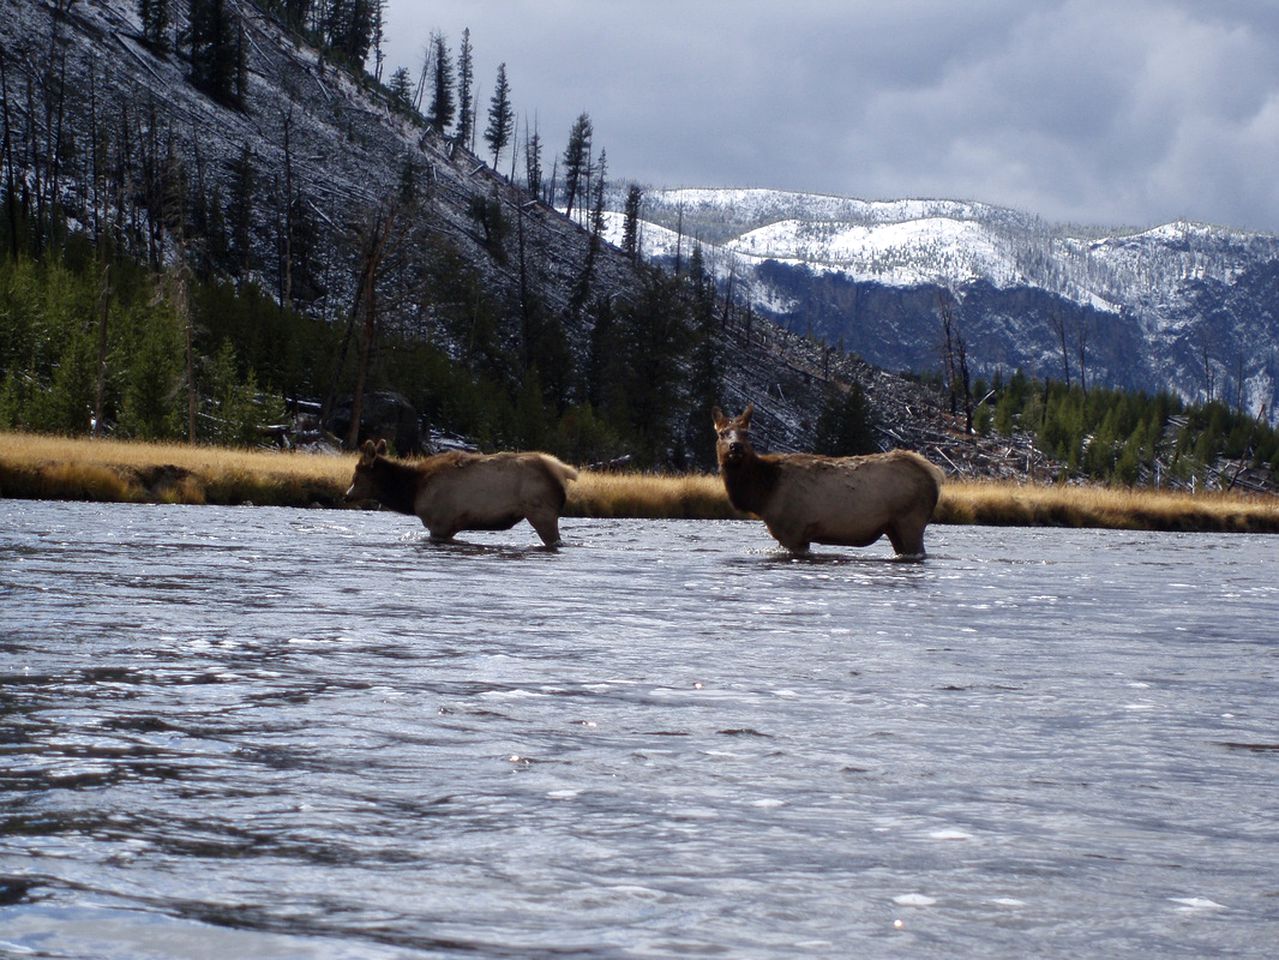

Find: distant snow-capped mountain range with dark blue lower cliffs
<box><xmin>610</xmin><ymin>189</ymin><xmax>1279</xmax><ymax>422</ymax></box>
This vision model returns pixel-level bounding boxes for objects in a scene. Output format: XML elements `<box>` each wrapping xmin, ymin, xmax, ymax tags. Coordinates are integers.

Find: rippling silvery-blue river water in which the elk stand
<box><xmin>0</xmin><ymin>501</ymin><xmax>1279</xmax><ymax>960</ymax></box>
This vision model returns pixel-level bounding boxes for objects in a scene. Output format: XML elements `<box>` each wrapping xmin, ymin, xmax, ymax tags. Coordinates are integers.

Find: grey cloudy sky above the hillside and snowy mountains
<box><xmin>386</xmin><ymin>0</ymin><xmax>1279</xmax><ymax>231</ymax></box>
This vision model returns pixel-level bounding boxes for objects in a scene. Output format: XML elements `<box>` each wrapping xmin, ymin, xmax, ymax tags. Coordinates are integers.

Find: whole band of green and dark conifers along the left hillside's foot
<box><xmin>0</xmin><ymin>204</ymin><xmax>723</xmax><ymax>468</ymax></box>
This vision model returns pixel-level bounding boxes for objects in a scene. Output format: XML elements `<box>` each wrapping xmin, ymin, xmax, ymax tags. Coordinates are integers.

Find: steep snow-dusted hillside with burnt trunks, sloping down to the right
<box><xmin>0</xmin><ymin>0</ymin><xmax>1043</xmax><ymax>465</ymax></box>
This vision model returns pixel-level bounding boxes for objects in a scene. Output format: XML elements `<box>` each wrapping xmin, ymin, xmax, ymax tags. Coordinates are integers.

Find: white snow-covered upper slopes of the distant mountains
<box><xmin>610</xmin><ymin>188</ymin><xmax>1279</xmax><ymax>315</ymax></box>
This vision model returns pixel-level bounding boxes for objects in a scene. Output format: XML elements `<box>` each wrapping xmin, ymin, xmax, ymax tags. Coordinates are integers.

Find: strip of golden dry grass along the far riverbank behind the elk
<box><xmin>0</xmin><ymin>433</ymin><xmax>1279</xmax><ymax>533</ymax></box>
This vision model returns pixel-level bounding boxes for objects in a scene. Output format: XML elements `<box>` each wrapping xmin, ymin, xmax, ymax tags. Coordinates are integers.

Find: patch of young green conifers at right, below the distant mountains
<box><xmin>973</xmin><ymin>371</ymin><xmax>1279</xmax><ymax>486</ymax></box>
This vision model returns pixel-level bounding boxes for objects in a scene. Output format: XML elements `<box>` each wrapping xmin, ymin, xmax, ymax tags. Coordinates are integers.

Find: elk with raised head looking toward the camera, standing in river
<box><xmin>714</xmin><ymin>406</ymin><xmax>941</xmax><ymax>559</ymax></box>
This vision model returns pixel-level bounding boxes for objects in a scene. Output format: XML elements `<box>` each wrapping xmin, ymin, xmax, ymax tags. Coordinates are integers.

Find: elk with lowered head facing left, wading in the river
<box><xmin>347</xmin><ymin>440</ymin><xmax>577</xmax><ymax>546</ymax></box>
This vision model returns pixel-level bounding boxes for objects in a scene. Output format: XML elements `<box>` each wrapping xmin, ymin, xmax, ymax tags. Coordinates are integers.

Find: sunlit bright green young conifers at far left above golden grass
<box><xmin>0</xmin><ymin>235</ymin><xmax>301</xmax><ymax>445</ymax></box>
